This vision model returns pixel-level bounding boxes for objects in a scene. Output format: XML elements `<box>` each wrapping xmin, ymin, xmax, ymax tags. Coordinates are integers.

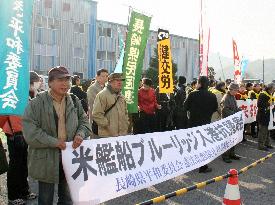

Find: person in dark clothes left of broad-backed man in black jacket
<box><xmin>175</xmin><ymin>76</ymin><xmax>187</xmax><ymax>129</ymax></box>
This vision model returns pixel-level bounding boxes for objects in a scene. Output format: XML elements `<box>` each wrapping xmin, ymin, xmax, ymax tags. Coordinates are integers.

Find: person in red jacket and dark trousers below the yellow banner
<box><xmin>138</xmin><ymin>78</ymin><xmax>161</xmax><ymax>134</ymax></box>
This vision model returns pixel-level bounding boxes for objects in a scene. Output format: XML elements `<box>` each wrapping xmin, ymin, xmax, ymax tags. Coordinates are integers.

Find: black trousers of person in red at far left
<box><xmin>7</xmin><ymin>133</ymin><xmax>29</xmax><ymax>200</ymax></box>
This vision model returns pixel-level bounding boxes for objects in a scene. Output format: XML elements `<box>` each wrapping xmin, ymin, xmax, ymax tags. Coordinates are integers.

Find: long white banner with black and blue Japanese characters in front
<box><xmin>62</xmin><ymin>112</ymin><xmax>244</xmax><ymax>205</ymax></box>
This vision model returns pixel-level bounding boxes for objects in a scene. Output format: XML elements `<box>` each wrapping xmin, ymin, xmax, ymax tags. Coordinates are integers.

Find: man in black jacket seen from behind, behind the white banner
<box><xmin>184</xmin><ymin>76</ymin><xmax>218</xmax><ymax>173</ymax></box>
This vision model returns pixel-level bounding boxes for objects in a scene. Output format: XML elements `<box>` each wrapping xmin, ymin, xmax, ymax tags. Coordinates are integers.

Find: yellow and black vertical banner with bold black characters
<box><xmin>158</xmin><ymin>29</ymin><xmax>174</xmax><ymax>93</ymax></box>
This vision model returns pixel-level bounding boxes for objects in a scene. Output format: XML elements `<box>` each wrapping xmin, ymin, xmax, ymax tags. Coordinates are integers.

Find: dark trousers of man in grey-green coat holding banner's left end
<box><xmin>38</xmin><ymin>162</ymin><xmax>73</xmax><ymax>205</ymax></box>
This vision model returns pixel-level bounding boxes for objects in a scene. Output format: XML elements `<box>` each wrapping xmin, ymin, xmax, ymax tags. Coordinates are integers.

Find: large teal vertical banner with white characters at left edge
<box><xmin>0</xmin><ymin>0</ymin><xmax>33</xmax><ymax>115</ymax></box>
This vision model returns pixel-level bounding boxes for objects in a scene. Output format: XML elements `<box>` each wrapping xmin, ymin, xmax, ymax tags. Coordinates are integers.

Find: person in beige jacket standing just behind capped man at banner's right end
<box><xmin>211</xmin><ymin>81</ymin><xmax>226</xmax><ymax>122</ymax></box>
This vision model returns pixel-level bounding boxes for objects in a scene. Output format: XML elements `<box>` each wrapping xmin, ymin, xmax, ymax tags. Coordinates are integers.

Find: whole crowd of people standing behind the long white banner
<box><xmin>0</xmin><ymin>66</ymin><xmax>275</xmax><ymax>205</ymax></box>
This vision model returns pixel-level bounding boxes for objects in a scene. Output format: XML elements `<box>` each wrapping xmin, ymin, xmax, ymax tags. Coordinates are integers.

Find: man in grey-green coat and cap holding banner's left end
<box><xmin>23</xmin><ymin>66</ymin><xmax>91</xmax><ymax>205</ymax></box>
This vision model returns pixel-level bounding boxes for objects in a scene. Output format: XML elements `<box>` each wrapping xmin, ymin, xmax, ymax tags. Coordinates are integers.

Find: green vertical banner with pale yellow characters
<box><xmin>122</xmin><ymin>11</ymin><xmax>151</xmax><ymax>113</ymax></box>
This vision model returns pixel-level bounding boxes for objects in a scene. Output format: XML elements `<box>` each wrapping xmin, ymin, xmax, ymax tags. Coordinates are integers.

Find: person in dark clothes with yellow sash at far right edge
<box><xmin>257</xmin><ymin>83</ymin><xmax>275</xmax><ymax>151</ymax></box>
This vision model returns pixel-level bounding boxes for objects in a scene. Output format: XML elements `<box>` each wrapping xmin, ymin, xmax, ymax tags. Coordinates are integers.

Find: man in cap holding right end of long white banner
<box><xmin>221</xmin><ymin>83</ymin><xmax>241</xmax><ymax>163</ymax></box>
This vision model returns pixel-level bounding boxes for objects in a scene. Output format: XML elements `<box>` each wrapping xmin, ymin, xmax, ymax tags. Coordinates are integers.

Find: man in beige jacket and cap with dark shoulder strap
<box><xmin>92</xmin><ymin>73</ymin><xmax>129</xmax><ymax>137</ymax></box>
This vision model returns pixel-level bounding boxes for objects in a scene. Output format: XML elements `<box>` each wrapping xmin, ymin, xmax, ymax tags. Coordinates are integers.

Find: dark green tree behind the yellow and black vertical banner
<box><xmin>144</xmin><ymin>48</ymin><xmax>178</xmax><ymax>87</ymax></box>
